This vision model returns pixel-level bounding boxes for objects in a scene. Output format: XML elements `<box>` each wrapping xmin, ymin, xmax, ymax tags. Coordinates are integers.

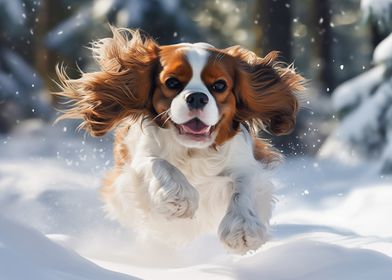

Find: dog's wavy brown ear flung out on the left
<box><xmin>54</xmin><ymin>27</ymin><xmax>159</xmax><ymax>136</ymax></box>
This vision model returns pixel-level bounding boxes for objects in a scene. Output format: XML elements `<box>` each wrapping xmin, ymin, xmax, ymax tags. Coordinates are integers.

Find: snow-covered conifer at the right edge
<box><xmin>319</xmin><ymin>0</ymin><xmax>392</xmax><ymax>173</ymax></box>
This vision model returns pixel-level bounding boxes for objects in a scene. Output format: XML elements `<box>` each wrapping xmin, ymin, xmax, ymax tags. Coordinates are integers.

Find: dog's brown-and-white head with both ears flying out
<box><xmin>58</xmin><ymin>28</ymin><xmax>303</xmax><ymax>148</ymax></box>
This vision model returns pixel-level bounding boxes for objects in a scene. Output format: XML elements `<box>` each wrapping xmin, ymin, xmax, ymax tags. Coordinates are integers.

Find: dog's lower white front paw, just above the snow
<box><xmin>218</xmin><ymin>211</ymin><xmax>267</xmax><ymax>255</ymax></box>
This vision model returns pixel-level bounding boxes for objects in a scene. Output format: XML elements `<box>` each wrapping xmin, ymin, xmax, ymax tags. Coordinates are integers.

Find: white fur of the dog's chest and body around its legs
<box><xmin>107</xmin><ymin>121</ymin><xmax>272</xmax><ymax>248</ymax></box>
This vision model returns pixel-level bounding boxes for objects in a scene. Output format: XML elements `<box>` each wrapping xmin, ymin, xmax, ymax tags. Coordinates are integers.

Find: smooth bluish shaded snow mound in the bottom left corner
<box><xmin>0</xmin><ymin>217</ymin><xmax>132</xmax><ymax>280</ymax></box>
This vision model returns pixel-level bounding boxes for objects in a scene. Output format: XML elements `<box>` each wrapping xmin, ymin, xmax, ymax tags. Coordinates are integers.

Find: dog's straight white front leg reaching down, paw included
<box><xmin>218</xmin><ymin>173</ymin><xmax>267</xmax><ymax>254</ymax></box>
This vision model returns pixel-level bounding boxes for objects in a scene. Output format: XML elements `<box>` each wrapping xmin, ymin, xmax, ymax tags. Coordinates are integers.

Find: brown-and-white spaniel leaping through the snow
<box><xmin>57</xmin><ymin>27</ymin><xmax>304</xmax><ymax>254</ymax></box>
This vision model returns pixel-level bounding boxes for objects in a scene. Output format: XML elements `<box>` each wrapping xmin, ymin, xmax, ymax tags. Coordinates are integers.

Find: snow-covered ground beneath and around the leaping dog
<box><xmin>0</xmin><ymin>123</ymin><xmax>392</xmax><ymax>280</ymax></box>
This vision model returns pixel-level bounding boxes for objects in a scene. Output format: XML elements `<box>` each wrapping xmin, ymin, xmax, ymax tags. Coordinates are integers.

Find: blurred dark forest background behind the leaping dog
<box><xmin>0</xmin><ymin>0</ymin><xmax>392</xmax><ymax>171</ymax></box>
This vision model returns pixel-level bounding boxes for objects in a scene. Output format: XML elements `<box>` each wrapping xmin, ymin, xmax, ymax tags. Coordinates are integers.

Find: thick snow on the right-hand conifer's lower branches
<box><xmin>319</xmin><ymin>73</ymin><xmax>392</xmax><ymax>167</ymax></box>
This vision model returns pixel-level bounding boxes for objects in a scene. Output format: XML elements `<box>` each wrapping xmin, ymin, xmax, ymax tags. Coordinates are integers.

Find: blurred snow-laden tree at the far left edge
<box><xmin>0</xmin><ymin>0</ymin><xmax>49</xmax><ymax>133</ymax></box>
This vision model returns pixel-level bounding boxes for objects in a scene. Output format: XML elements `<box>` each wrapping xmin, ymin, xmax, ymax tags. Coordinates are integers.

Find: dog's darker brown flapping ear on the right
<box><xmin>224</xmin><ymin>46</ymin><xmax>304</xmax><ymax>135</ymax></box>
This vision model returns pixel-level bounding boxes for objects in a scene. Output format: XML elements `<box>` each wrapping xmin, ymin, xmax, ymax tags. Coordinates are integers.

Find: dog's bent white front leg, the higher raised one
<box><xmin>138</xmin><ymin>158</ymin><xmax>199</xmax><ymax>219</ymax></box>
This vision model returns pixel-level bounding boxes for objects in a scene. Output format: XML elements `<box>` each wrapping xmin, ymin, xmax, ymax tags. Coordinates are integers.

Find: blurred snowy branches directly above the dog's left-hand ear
<box><xmin>45</xmin><ymin>0</ymin><xmax>205</xmax><ymax>68</ymax></box>
